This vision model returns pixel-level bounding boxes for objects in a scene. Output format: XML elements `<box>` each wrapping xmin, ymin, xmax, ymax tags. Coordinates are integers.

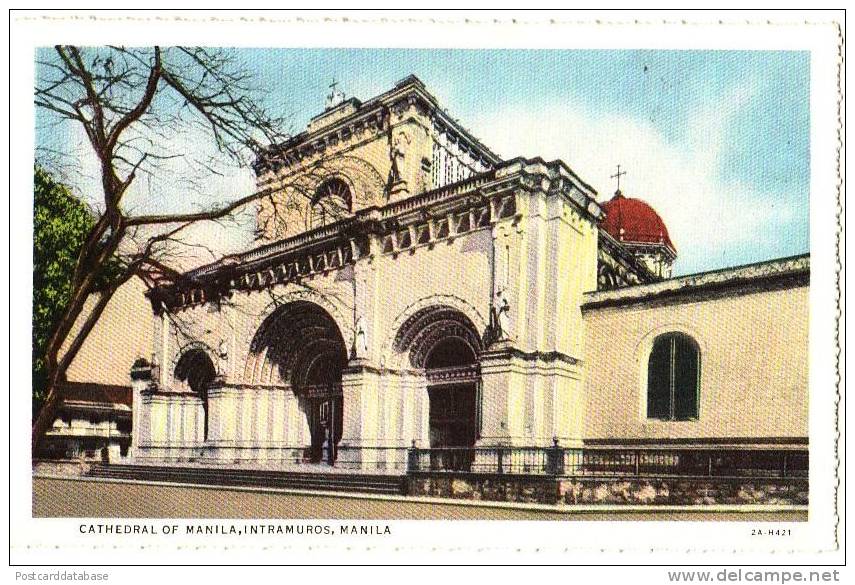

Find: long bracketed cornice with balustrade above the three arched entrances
<box><xmin>152</xmin><ymin>159</ymin><xmax>602</xmax><ymax>312</ymax></box>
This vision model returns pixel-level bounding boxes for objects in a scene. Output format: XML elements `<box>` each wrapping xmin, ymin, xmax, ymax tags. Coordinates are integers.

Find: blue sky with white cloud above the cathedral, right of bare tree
<box><xmin>35</xmin><ymin>49</ymin><xmax>810</xmax><ymax>273</ymax></box>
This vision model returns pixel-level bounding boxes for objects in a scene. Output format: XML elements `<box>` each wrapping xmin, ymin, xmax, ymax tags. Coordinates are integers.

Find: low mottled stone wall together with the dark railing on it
<box><xmin>407</xmin><ymin>443</ymin><xmax>809</xmax><ymax>505</ymax></box>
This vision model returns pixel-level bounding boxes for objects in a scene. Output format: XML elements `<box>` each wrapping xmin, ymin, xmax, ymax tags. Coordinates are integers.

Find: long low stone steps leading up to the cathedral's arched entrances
<box><xmin>87</xmin><ymin>464</ymin><xmax>406</xmax><ymax>495</ymax></box>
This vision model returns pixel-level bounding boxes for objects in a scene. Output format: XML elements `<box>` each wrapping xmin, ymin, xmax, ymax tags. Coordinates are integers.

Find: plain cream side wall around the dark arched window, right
<box><xmin>584</xmin><ymin>286</ymin><xmax>809</xmax><ymax>442</ymax></box>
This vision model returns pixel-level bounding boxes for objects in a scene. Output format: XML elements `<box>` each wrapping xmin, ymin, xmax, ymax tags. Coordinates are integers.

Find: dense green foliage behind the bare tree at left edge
<box><xmin>33</xmin><ymin>165</ymin><xmax>95</xmax><ymax>414</ymax></box>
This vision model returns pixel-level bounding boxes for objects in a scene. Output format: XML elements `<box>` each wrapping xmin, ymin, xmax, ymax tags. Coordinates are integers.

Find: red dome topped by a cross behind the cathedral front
<box><xmin>600</xmin><ymin>191</ymin><xmax>677</xmax><ymax>252</ymax></box>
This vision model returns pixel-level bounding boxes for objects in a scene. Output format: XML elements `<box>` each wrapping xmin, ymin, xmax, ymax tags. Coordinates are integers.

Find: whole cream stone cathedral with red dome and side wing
<box><xmin>131</xmin><ymin>76</ymin><xmax>809</xmax><ymax>498</ymax></box>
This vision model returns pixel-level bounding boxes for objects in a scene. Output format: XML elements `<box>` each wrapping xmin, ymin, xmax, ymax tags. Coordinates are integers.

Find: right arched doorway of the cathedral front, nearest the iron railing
<box><xmin>395</xmin><ymin>306</ymin><xmax>483</xmax><ymax>470</ymax></box>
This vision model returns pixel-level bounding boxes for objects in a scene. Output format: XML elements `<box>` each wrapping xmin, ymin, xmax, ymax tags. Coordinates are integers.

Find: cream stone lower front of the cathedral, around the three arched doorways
<box><xmin>135</xmin><ymin>153</ymin><xmax>598</xmax><ymax>468</ymax></box>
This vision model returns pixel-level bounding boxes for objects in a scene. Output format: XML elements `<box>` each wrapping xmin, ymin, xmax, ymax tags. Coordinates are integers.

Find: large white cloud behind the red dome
<box><xmin>473</xmin><ymin>97</ymin><xmax>804</xmax><ymax>273</ymax></box>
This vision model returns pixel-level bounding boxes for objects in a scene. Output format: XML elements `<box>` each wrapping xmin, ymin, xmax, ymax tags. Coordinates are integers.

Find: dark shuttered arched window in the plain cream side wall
<box><xmin>647</xmin><ymin>333</ymin><xmax>701</xmax><ymax>420</ymax></box>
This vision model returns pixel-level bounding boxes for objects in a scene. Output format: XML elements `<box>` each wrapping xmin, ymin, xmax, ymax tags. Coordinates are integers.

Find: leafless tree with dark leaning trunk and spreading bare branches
<box><xmin>32</xmin><ymin>45</ymin><xmax>287</xmax><ymax>454</ymax></box>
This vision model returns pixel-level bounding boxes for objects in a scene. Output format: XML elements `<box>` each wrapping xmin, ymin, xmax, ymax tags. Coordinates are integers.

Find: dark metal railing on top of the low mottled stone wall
<box><xmin>407</xmin><ymin>445</ymin><xmax>809</xmax><ymax>478</ymax></box>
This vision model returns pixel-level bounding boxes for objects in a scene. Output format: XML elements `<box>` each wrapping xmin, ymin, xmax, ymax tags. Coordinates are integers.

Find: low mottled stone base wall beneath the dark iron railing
<box><xmin>408</xmin><ymin>473</ymin><xmax>808</xmax><ymax>506</ymax></box>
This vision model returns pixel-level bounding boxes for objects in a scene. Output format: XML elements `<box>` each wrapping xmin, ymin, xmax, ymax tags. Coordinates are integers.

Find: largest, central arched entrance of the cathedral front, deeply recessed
<box><xmin>250</xmin><ymin>301</ymin><xmax>347</xmax><ymax>465</ymax></box>
